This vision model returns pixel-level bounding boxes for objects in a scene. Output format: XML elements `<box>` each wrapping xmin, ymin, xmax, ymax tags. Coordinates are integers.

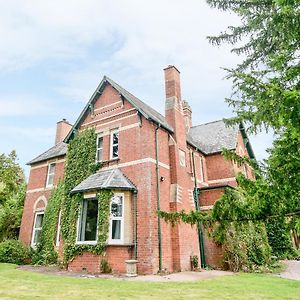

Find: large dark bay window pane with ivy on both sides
<box><xmin>77</xmin><ymin>198</ymin><xmax>98</xmax><ymax>243</ymax></box>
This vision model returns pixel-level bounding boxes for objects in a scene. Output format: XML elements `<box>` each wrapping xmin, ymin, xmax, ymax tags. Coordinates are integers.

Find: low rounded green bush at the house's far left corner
<box><xmin>0</xmin><ymin>240</ymin><xmax>30</xmax><ymax>265</ymax></box>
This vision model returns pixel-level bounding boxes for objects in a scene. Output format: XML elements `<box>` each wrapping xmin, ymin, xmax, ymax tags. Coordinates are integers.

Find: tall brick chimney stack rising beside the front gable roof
<box><xmin>164</xmin><ymin>66</ymin><xmax>186</xmax><ymax>145</ymax></box>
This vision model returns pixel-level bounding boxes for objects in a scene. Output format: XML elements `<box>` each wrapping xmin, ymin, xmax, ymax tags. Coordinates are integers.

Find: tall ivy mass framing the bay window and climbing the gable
<box><xmin>61</xmin><ymin>129</ymin><xmax>112</xmax><ymax>263</ymax></box>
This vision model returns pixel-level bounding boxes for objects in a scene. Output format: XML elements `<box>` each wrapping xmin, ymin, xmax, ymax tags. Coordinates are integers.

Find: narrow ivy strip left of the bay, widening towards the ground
<box><xmin>32</xmin><ymin>182</ymin><xmax>64</xmax><ymax>265</ymax></box>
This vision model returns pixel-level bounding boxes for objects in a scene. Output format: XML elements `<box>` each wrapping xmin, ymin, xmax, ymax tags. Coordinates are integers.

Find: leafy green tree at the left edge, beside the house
<box><xmin>0</xmin><ymin>151</ymin><xmax>26</xmax><ymax>241</ymax></box>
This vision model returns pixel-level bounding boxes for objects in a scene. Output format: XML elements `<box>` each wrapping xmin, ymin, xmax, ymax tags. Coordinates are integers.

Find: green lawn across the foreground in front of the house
<box><xmin>0</xmin><ymin>264</ymin><xmax>300</xmax><ymax>300</ymax></box>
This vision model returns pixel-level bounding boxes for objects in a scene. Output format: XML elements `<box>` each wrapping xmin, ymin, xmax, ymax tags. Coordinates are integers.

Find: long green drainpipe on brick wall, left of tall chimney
<box><xmin>155</xmin><ymin>125</ymin><xmax>162</xmax><ymax>273</ymax></box>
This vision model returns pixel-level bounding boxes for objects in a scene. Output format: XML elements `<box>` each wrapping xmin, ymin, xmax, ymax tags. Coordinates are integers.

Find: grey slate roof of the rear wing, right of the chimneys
<box><xmin>187</xmin><ymin>120</ymin><xmax>239</xmax><ymax>154</ymax></box>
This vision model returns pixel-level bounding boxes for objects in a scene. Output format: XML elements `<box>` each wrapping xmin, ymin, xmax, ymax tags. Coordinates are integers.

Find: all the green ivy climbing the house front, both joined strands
<box><xmin>33</xmin><ymin>129</ymin><xmax>113</xmax><ymax>264</ymax></box>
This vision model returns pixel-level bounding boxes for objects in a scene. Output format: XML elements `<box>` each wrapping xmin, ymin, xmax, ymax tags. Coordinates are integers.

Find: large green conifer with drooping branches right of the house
<box><xmin>164</xmin><ymin>0</ymin><xmax>300</xmax><ymax>268</ymax></box>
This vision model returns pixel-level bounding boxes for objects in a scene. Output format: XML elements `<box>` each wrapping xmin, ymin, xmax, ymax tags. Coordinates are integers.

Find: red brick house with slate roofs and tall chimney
<box><xmin>20</xmin><ymin>66</ymin><xmax>254</xmax><ymax>273</ymax></box>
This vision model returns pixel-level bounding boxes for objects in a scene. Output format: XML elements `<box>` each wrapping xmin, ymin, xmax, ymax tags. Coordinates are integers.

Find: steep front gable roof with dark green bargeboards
<box><xmin>64</xmin><ymin>76</ymin><xmax>173</xmax><ymax>142</ymax></box>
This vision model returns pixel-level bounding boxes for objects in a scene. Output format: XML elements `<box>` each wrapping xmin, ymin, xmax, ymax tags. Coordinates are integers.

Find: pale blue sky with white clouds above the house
<box><xmin>0</xmin><ymin>0</ymin><xmax>272</xmax><ymax>176</ymax></box>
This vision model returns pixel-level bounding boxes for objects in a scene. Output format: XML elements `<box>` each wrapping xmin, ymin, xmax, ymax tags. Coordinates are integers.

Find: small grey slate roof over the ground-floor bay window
<box><xmin>71</xmin><ymin>168</ymin><xmax>137</xmax><ymax>194</ymax></box>
